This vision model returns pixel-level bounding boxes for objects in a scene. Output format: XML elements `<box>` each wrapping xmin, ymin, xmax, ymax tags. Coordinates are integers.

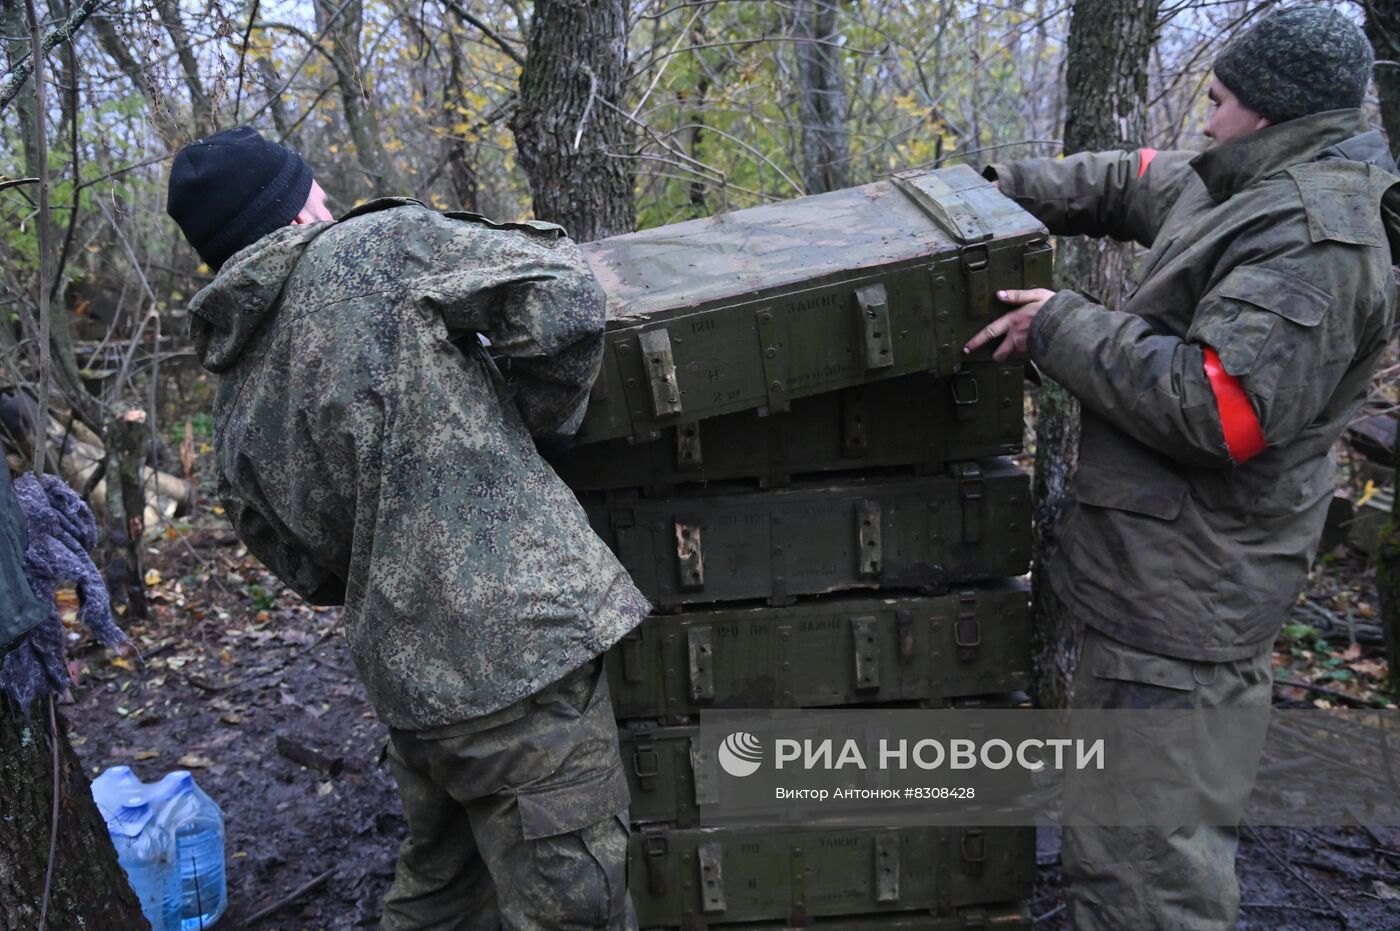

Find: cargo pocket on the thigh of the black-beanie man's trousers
<box><xmin>517</xmin><ymin>767</ymin><xmax>630</xmax><ymax>928</ymax></box>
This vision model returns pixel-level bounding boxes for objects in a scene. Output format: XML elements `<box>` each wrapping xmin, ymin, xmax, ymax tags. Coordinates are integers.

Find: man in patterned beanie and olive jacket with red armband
<box><xmin>969</xmin><ymin>7</ymin><xmax>1400</xmax><ymax>931</ymax></box>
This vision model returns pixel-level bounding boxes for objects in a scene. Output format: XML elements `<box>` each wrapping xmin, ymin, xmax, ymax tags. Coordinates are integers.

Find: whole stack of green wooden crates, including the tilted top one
<box><xmin>556</xmin><ymin>168</ymin><xmax>1051</xmax><ymax>931</ymax></box>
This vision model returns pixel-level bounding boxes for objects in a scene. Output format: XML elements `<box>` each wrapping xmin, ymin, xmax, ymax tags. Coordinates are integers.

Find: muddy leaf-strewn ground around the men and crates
<box><xmin>63</xmin><ymin>522</ymin><xmax>1400</xmax><ymax>931</ymax></box>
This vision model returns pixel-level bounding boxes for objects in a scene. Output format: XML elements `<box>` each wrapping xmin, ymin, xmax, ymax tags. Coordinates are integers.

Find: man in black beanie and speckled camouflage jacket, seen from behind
<box><xmin>171</xmin><ymin>130</ymin><xmax>650</xmax><ymax>931</ymax></box>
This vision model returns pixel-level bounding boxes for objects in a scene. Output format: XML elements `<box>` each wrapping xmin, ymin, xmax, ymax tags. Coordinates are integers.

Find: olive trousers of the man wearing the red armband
<box><xmin>1061</xmin><ymin>629</ymin><xmax>1273</xmax><ymax>931</ymax></box>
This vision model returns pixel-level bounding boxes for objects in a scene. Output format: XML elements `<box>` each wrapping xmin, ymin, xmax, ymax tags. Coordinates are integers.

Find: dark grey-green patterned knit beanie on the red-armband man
<box><xmin>1215</xmin><ymin>7</ymin><xmax>1375</xmax><ymax>123</ymax></box>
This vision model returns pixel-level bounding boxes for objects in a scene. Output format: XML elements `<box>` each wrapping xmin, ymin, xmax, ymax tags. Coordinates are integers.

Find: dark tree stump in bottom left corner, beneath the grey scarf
<box><xmin>0</xmin><ymin>699</ymin><xmax>151</xmax><ymax>931</ymax></box>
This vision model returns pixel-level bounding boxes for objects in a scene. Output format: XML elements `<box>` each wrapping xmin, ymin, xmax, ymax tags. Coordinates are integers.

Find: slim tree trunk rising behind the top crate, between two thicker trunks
<box><xmin>797</xmin><ymin>0</ymin><xmax>851</xmax><ymax>195</ymax></box>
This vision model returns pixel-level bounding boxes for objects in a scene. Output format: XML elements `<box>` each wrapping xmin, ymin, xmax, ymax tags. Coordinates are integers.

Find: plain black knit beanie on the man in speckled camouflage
<box><xmin>165</xmin><ymin>126</ymin><xmax>311</xmax><ymax>272</ymax></box>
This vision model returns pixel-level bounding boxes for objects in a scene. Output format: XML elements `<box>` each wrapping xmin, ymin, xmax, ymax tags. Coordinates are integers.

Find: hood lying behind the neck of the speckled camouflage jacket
<box><xmin>189</xmin><ymin>223</ymin><xmax>335</xmax><ymax>372</ymax></box>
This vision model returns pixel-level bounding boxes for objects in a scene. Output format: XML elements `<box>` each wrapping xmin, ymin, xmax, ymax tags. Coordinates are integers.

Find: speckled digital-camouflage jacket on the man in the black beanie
<box><xmin>189</xmin><ymin>200</ymin><xmax>650</xmax><ymax>729</ymax></box>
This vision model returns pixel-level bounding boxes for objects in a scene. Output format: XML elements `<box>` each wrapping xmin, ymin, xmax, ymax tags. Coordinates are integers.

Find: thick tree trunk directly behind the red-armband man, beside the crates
<box><xmin>1033</xmin><ymin>0</ymin><xmax>1159</xmax><ymax>708</ymax></box>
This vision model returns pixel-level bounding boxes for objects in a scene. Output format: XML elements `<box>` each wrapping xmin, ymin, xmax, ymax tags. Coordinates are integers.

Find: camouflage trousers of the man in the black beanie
<box><xmin>381</xmin><ymin>659</ymin><xmax>637</xmax><ymax>931</ymax></box>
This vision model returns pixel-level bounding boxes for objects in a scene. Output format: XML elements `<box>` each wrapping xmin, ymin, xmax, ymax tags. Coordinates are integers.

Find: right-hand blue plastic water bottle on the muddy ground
<box><xmin>151</xmin><ymin>770</ymin><xmax>228</xmax><ymax>931</ymax></box>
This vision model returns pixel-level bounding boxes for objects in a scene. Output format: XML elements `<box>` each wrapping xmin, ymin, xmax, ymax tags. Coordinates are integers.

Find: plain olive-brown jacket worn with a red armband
<box><xmin>991</xmin><ymin>111</ymin><xmax>1400</xmax><ymax>661</ymax></box>
